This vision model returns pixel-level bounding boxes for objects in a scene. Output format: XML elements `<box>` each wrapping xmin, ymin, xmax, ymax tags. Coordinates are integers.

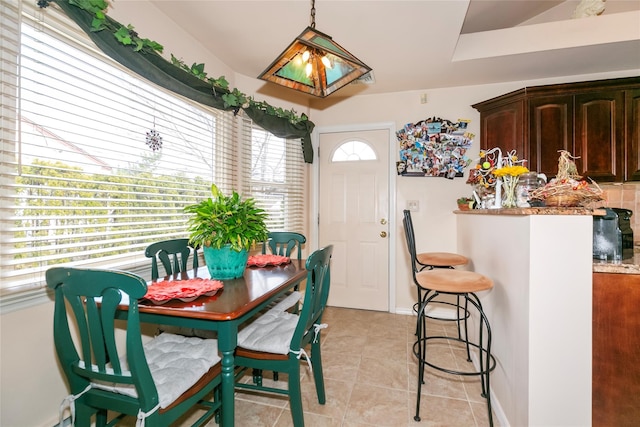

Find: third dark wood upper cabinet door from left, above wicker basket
<box><xmin>574</xmin><ymin>90</ymin><xmax>624</xmax><ymax>182</ymax></box>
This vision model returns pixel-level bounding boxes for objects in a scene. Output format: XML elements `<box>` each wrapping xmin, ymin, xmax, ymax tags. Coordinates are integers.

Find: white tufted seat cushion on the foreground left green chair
<box><xmin>93</xmin><ymin>333</ymin><xmax>220</xmax><ymax>408</ymax></box>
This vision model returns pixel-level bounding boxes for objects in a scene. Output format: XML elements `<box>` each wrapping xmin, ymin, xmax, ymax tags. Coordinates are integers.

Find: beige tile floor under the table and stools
<box><xmin>119</xmin><ymin>307</ymin><xmax>495</xmax><ymax>427</ymax></box>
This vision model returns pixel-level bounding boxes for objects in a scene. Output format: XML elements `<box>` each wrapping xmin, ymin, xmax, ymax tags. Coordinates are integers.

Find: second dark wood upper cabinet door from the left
<box><xmin>527</xmin><ymin>95</ymin><xmax>573</xmax><ymax>178</ymax></box>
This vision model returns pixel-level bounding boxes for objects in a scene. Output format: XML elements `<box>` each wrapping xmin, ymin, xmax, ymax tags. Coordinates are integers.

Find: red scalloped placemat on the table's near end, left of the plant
<box><xmin>143</xmin><ymin>278</ymin><xmax>223</xmax><ymax>304</ymax></box>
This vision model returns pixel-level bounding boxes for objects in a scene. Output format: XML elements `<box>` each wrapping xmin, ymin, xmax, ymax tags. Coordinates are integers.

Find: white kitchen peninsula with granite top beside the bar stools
<box><xmin>456</xmin><ymin>208</ymin><xmax>594</xmax><ymax>426</ymax></box>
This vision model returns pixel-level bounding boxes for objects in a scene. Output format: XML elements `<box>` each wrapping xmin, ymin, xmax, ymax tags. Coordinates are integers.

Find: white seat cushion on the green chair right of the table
<box><xmin>238</xmin><ymin>307</ymin><xmax>298</xmax><ymax>354</ymax></box>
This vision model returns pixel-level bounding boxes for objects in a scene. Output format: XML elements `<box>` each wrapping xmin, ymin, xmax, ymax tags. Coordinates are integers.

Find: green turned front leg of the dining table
<box><xmin>218</xmin><ymin>322</ymin><xmax>238</xmax><ymax>427</ymax></box>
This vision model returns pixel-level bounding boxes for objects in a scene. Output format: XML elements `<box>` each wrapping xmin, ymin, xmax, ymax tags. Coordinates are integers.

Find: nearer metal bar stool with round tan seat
<box><xmin>413</xmin><ymin>269</ymin><xmax>496</xmax><ymax>426</ymax></box>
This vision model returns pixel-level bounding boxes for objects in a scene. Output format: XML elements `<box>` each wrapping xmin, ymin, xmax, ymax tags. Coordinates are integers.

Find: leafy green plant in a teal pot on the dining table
<box><xmin>184</xmin><ymin>184</ymin><xmax>268</xmax><ymax>280</ymax></box>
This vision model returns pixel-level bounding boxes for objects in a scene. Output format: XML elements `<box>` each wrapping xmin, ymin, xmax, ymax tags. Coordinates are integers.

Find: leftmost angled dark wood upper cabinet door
<box><xmin>480</xmin><ymin>99</ymin><xmax>528</xmax><ymax>158</ymax></box>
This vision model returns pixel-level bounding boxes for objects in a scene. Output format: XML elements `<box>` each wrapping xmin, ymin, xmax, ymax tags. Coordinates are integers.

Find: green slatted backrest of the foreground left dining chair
<box><xmin>46</xmin><ymin>267</ymin><xmax>158</xmax><ymax>409</ymax></box>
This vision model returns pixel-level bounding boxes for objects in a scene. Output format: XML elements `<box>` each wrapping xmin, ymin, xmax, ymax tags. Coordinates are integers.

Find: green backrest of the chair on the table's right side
<box><xmin>291</xmin><ymin>245</ymin><xmax>333</xmax><ymax>349</ymax></box>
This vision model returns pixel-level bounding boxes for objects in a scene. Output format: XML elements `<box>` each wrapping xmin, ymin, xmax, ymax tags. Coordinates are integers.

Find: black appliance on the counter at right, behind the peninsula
<box><xmin>593</xmin><ymin>208</ymin><xmax>633</xmax><ymax>261</ymax></box>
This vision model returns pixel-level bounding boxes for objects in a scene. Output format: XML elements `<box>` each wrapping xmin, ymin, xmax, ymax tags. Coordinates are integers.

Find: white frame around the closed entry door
<box><xmin>310</xmin><ymin>122</ymin><xmax>398</xmax><ymax>313</ymax></box>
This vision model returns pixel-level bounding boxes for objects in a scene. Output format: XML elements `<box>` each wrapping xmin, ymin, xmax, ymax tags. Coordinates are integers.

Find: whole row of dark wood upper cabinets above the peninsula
<box><xmin>473</xmin><ymin>77</ymin><xmax>640</xmax><ymax>182</ymax></box>
